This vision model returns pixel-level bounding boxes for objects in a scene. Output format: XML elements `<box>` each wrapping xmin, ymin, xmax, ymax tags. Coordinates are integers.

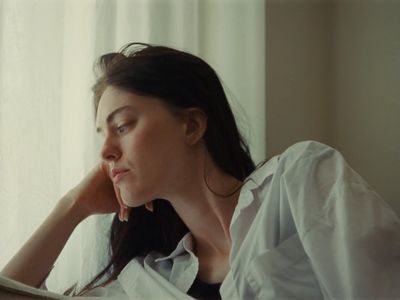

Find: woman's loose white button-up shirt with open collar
<box><xmin>73</xmin><ymin>141</ymin><xmax>400</xmax><ymax>300</ymax></box>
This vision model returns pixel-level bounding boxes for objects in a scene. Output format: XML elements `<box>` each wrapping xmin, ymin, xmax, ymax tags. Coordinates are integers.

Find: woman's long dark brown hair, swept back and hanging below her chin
<box><xmin>69</xmin><ymin>43</ymin><xmax>255</xmax><ymax>295</ymax></box>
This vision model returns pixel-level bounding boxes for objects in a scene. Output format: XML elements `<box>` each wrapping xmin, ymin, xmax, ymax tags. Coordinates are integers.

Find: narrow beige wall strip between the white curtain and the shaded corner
<box><xmin>267</xmin><ymin>1</ymin><xmax>332</xmax><ymax>156</ymax></box>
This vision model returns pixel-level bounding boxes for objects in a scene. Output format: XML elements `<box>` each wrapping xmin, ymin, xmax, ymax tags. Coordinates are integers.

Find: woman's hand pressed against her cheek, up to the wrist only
<box><xmin>67</xmin><ymin>163</ymin><xmax>130</xmax><ymax>221</ymax></box>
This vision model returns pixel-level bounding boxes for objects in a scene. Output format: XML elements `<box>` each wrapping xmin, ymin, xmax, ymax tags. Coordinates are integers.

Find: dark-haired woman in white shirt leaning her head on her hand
<box><xmin>2</xmin><ymin>44</ymin><xmax>400</xmax><ymax>299</ymax></box>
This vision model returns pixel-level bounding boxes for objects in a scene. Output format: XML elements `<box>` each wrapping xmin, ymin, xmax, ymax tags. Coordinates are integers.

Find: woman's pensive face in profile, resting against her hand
<box><xmin>96</xmin><ymin>86</ymin><xmax>188</xmax><ymax>207</ymax></box>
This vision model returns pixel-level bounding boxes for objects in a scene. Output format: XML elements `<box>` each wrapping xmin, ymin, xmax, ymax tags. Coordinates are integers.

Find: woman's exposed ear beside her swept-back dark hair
<box><xmin>185</xmin><ymin>108</ymin><xmax>207</xmax><ymax>145</ymax></box>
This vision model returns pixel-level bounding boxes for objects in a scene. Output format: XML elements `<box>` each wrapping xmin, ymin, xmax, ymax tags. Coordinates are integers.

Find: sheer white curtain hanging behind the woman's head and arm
<box><xmin>0</xmin><ymin>0</ymin><xmax>266</xmax><ymax>291</ymax></box>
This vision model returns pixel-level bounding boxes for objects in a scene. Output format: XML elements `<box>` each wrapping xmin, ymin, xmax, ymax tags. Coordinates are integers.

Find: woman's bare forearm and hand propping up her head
<box><xmin>0</xmin><ymin>165</ymin><xmax>128</xmax><ymax>287</ymax></box>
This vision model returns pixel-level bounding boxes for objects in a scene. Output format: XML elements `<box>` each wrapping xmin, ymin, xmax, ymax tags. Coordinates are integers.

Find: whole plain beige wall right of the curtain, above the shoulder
<box><xmin>267</xmin><ymin>0</ymin><xmax>400</xmax><ymax>213</ymax></box>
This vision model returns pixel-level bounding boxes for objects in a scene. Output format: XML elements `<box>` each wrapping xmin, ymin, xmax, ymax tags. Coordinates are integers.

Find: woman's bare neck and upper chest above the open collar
<box><xmin>171</xmin><ymin>164</ymin><xmax>241</xmax><ymax>257</ymax></box>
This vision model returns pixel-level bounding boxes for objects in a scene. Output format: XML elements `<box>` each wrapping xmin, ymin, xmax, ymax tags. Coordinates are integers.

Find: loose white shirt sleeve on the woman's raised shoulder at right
<box><xmin>281</xmin><ymin>143</ymin><xmax>400</xmax><ymax>299</ymax></box>
